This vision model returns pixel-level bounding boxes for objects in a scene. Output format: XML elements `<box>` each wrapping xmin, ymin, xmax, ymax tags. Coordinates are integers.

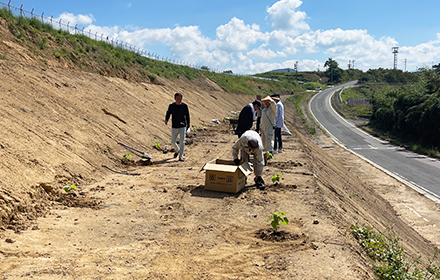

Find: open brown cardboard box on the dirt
<box><xmin>203</xmin><ymin>159</ymin><xmax>253</xmax><ymax>193</ymax></box>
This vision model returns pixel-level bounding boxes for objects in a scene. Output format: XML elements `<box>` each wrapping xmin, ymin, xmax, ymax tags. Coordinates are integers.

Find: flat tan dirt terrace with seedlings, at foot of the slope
<box><xmin>0</xmin><ymin>123</ymin><xmax>378</xmax><ymax>279</ymax></box>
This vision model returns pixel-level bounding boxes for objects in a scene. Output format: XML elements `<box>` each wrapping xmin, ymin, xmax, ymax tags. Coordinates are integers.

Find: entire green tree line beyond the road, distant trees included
<box><xmin>324</xmin><ymin>58</ymin><xmax>440</xmax><ymax>150</ymax></box>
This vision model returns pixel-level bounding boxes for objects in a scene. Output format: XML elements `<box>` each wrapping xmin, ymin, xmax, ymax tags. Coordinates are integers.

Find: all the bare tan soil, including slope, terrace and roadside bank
<box><xmin>0</xmin><ymin>18</ymin><xmax>440</xmax><ymax>279</ymax></box>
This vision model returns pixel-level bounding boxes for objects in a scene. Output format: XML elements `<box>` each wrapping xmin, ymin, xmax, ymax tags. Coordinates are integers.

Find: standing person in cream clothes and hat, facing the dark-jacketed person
<box><xmin>261</xmin><ymin>96</ymin><xmax>277</xmax><ymax>159</ymax></box>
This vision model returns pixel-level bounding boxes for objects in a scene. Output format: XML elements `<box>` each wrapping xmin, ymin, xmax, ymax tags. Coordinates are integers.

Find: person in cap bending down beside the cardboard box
<box><xmin>232</xmin><ymin>130</ymin><xmax>265</xmax><ymax>190</ymax></box>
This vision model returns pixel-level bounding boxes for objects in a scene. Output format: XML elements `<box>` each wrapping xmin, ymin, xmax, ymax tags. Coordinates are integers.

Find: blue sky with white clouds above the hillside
<box><xmin>0</xmin><ymin>0</ymin><xmax>440</xmax><ymax>74</ymax></box>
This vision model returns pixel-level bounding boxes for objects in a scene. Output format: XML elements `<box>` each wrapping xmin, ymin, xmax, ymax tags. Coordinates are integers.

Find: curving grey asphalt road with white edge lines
<box><xmin>309</xmin><ymin>82</ymin><xmax>440</xmax><ymax>201</ymax></box>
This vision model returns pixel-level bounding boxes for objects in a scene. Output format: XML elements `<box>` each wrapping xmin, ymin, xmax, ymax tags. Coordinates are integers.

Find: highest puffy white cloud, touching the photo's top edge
<box><xmin>266</xmin><ymin>0</ymin><xmax>310</xmax><ymax>36</ymax></box>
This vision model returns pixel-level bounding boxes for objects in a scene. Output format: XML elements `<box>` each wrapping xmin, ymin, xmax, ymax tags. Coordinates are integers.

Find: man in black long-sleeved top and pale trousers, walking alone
<box><xmin>165</xmin><ymin>92</ymin><xmax>190</xmax><ymax>161</ymax></box>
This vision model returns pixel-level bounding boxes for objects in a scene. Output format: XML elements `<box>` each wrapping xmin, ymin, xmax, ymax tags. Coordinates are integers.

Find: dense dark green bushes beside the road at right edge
<box><xmin>370</xmin><ymin>70</ymin><xmax>440</xmax><ymax>150</ymax></box>
